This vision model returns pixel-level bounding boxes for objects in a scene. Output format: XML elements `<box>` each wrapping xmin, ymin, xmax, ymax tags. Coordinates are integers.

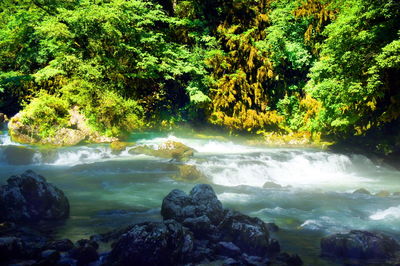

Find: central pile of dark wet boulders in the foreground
<box><xmin>107</xmin><ymin>185</ymin><xmax>302</xmax><ymax>265</ymax></box>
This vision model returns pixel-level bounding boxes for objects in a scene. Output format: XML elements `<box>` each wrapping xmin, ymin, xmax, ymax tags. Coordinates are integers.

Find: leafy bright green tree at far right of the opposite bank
<box><xmin>307</xmin><ymin>0</ymin><xmax>400</xmax><ymax>136</ymax></box>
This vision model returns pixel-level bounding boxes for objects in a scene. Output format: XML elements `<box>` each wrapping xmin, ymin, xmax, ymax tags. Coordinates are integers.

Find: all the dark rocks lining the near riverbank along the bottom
<box><xmin>0</xmin><ymin>171</ymin><xmax>400</xmax><ymax>265</ymax></box>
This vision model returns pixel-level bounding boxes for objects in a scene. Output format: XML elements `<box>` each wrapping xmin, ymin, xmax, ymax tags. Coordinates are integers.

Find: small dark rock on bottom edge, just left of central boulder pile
<box><xmin>69</xmin><ymin>239</ymin><xmax>99</xmax><ymax>265</ymax></box>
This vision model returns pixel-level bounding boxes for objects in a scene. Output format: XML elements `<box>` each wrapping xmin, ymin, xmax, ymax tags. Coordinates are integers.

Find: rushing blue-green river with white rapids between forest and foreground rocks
<box><xmin>0</xmin><ymin>129</ymin><xmax>400</xmax><ymax>265</ymax></box>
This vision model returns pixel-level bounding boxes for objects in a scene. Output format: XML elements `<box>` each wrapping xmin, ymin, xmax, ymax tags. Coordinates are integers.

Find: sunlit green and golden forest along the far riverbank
<box><xmin>0</xmin><ymin>0</ymin><xmax>400</xmax><ymax>154</ymax></box>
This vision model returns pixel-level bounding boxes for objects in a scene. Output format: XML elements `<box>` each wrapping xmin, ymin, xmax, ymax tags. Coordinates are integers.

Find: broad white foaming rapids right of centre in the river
<box><xmin>198</xmin><ymin>150</ymin><xmax>374</xmax><ymax>189</ymax></box>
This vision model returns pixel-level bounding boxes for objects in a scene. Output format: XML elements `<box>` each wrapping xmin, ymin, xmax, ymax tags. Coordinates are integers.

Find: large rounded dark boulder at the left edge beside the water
<box><xmin>0</xmin><ymin>170</ymin><xmax>69</xmax><ymax>223</ymax></box>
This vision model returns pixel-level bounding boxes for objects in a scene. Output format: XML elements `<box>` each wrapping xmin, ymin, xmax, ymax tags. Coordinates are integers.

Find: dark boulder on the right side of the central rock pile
<box><xmin>218</xmin><ymin>211</ymin><xmax>276</xmax><ymax>256</ymax></box>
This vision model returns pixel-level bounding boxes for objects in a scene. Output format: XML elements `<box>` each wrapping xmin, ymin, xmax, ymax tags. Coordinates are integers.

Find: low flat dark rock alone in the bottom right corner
<box><xmin>321</xmin><ymin>230</ymin><xmax>400</xmax><ymax>259</ymax></box>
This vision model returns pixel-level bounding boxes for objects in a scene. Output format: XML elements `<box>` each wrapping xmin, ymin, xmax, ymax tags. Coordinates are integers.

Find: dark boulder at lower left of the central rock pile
<box><xmin>108</xmin><ymin>220</ymin><xmax>193</xmax><ymax>265</ymax></box>
